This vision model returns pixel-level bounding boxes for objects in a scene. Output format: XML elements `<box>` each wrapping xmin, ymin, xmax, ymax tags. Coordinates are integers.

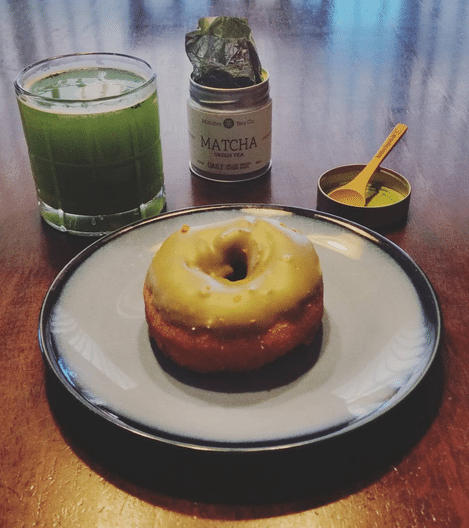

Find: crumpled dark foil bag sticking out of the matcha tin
<box><xmin>186</xmin><ymin>16</ymin><xmax>262</xmax><ymax>88</ymax></box>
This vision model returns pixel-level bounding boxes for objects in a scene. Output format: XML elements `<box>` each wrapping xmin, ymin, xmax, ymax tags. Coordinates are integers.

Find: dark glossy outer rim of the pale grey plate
<box><xmin>38</xmin><ymin>203</ymin><xmax>442</xmax><ymax>453</ymax></box>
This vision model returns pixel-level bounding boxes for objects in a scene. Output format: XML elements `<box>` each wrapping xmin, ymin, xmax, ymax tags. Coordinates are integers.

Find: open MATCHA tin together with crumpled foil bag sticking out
<box><xmin>186</xmin><ymin>17</ymin><xmax>272</xmax><ymax>182</ymax></box>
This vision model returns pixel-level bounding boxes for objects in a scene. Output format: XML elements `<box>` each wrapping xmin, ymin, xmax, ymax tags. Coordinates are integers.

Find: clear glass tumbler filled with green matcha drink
<box><xmin>15</xmin><ymin>54</ymin><xmax>165</xmax><ymax>234</ymax></box>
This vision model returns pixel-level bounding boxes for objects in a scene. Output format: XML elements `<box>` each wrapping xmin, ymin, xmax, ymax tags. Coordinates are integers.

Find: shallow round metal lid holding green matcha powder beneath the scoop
<box><xmin>317</xmin><ymin>165</ymin><xmax>411</xmax><ymax>231</ymax></box>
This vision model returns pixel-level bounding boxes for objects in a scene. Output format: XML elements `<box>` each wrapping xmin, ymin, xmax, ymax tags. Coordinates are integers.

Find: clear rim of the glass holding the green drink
<box><xmin>13</xmin><ymin>51</ymin><xmax>156</xmax><ymax>105</ymax></box>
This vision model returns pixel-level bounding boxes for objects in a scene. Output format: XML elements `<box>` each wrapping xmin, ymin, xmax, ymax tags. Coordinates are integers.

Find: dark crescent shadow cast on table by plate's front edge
<box><xmin>47</xmin><ymin>344</ymin><xmax>443</xmax><ymax>508</ymax></box>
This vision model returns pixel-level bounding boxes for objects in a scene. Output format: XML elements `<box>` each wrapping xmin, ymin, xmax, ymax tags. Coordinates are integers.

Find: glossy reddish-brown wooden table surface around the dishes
<box><xmin>0</xmin><ymin>0</ymin><xmax>469</xmax><ymax>528</ymax></box>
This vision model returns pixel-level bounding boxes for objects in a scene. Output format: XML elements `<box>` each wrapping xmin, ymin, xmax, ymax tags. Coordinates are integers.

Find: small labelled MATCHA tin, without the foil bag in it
<box><xmin>187</xmin><ymin>70</ymin><xmax>272</xmax><ymax>182</ymax></box>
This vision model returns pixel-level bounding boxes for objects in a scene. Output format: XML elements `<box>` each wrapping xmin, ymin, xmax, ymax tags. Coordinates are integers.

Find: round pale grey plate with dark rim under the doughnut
<box><xmin>39</xmin><ymin>205</ymin><xmax>441</xmax><ymax>451</ymax></box>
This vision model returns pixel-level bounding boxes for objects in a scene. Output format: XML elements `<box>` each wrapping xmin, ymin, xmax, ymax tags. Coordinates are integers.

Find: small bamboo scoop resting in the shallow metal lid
<box><xmin>328</xmin><ymin>123</ymin><xmax>407</xmax><ymax>207</ymax></box>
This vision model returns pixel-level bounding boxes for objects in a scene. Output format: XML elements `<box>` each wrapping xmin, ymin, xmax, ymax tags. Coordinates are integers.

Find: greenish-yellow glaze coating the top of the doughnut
<box><xmin>145</xmin><ymin>216</ymin><xmax>322</xmax><ymax>330</ymax></box>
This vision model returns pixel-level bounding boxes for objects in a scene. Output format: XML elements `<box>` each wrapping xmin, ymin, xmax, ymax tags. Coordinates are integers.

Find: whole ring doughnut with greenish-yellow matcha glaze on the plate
<box><xmin>144</xmin><ymin>217</ymin><xmax>323</xmax><ymax>372</ymax></box>
